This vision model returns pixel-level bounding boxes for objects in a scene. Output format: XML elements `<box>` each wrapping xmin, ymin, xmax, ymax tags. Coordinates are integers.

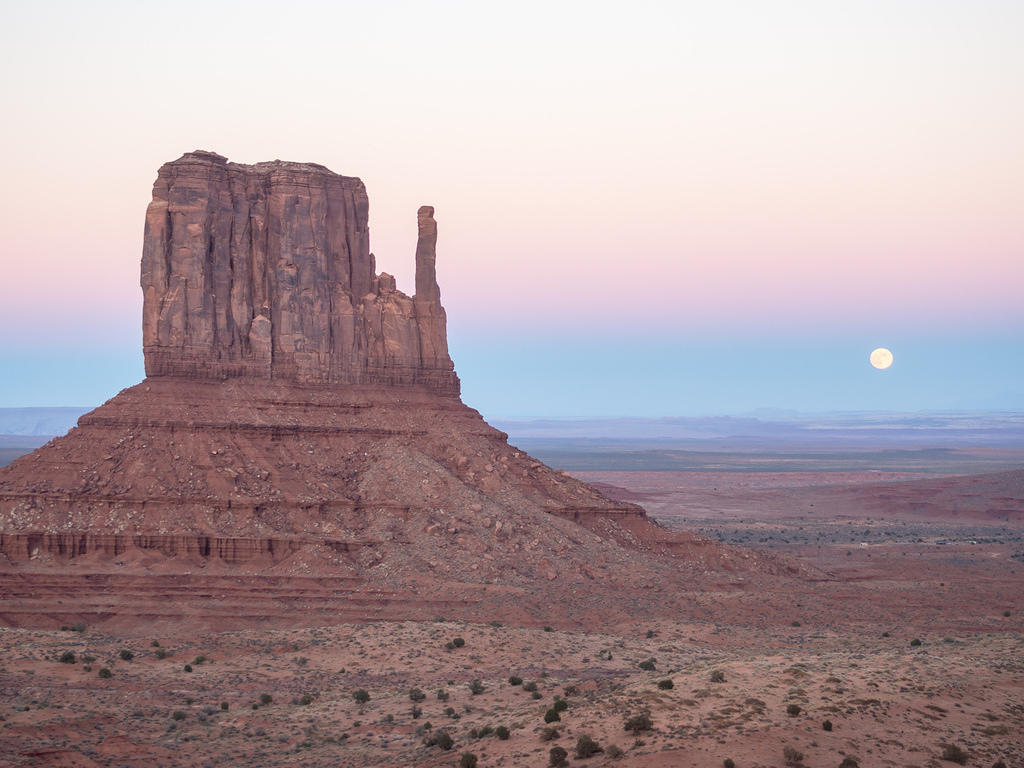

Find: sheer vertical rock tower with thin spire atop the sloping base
<box><xmin>141</xmin><ymin>152</ymin><xmax>459</xmax><ymax>396</ymax></box>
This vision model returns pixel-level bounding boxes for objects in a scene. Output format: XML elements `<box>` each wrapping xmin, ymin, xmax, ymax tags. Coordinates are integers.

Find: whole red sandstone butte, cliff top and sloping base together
<box><xmin>0</xmin><ymin>152</ymin><xmax>791</xmax><ymax>630</ymax></box>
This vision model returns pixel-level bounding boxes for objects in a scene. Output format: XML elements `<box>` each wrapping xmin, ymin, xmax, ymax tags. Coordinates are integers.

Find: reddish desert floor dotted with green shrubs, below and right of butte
<box><xmin>0</xmin><ymin>448</ymin><xmax>1024</xmax><ymax>768</ymax></box>
